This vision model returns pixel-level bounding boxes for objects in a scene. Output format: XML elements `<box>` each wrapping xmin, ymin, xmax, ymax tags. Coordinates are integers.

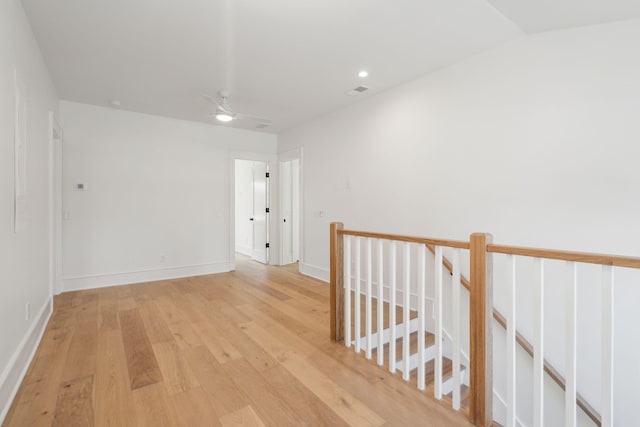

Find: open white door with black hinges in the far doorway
<box><xmin>251</xmin><ymin>162</ymin><xmax>269</xmax><ymax>264</ymax></box>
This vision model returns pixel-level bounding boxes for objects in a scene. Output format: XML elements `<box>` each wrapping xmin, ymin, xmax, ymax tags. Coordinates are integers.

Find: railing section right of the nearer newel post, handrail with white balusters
<box><xmin>484</xmin><ymin>244</ymin><xmax>640</xmax><ymax>427</ymax></box>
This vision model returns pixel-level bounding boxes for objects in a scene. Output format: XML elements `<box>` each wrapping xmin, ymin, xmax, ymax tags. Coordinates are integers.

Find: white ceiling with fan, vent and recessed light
<box><xmin>23</xmin><ymin>0</ymin><xmax>640</xmax><ymax>132</ymax></box>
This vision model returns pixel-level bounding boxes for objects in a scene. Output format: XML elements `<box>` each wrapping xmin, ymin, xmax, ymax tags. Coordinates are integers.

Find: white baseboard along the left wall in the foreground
<box><xmin>0</xmin><ymin>297</ymin><xmax>53</xmax><ymax>424</ymax></box>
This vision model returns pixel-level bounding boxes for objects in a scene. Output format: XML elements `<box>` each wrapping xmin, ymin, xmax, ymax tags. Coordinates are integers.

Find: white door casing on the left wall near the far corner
<box><xmin>49</xmin><ymin>111</ymin><xmax>63</xmax><ymax>296</ymax></box>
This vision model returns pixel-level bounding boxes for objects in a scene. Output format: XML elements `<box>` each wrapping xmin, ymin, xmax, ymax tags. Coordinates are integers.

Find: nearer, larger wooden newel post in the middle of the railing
<box><xmin>470</xmin><ymin>233</ymin><xmax>493</xmax><ymax>427</ymax></box>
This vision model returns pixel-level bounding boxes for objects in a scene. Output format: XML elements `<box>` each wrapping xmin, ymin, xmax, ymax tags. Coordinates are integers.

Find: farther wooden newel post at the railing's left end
<box><xmin>330</xmin><ymin>222</ymin><xmax>344</xmax><ymax>341</ymax></box>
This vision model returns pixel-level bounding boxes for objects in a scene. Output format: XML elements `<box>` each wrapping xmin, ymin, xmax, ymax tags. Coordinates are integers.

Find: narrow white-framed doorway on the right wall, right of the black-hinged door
<box><xmin>280</xmin><ymin>159</ymin><xmax>300</xmax><ymax>265</ymax></box>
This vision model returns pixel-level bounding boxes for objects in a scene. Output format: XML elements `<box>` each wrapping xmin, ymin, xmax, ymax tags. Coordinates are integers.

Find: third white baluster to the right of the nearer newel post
<box><xmin>564</xmin><ymin>261</ymin><xmax>578</xmax><ymax>427</ymax></box>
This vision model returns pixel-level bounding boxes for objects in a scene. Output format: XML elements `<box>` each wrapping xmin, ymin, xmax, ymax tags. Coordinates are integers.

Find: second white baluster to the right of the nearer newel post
<box><xmin>533</xmin><ymin>258</ymin><xmax>544</xmax><ymax>427</ymax></box>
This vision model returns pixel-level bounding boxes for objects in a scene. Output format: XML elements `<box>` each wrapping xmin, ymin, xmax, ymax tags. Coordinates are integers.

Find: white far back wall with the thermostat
<box><xmin>60</xmin><ymin>102</ymin><xmax>276</xmax><ymax>290</ymax></box>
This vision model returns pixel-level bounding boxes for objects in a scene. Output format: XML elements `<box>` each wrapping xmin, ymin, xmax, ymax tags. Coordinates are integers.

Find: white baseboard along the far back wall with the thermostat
<box><xmin>62</xmin><ymin>262</ymin><xmax>231</xmax><ymax>292</ymax></box>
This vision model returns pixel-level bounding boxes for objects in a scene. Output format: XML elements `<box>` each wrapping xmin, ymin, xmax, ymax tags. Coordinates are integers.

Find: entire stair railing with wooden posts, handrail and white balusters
<box><xmin>331</xmin><ymin>223</ymin><xmax>640</xmax><ymax>427</ymax></box>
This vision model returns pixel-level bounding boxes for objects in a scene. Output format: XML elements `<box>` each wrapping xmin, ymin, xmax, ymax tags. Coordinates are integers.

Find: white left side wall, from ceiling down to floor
<box><xmin>0</xmin><ymin>0</ymin><xmax>57</xmax><ymax>423</ymax></box>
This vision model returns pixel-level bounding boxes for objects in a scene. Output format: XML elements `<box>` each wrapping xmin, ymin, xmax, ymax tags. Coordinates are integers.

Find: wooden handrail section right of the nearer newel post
<box><xmin>487</xmin><ymin>244</ymin><xmax>640</xmax><ymax>268</ymax></box>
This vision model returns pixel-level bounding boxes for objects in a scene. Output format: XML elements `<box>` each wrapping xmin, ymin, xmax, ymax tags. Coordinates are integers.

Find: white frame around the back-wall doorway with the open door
<box><xmin>228</xmin><ymin>151</ymin><xmax>280</xmax><ymax>271</ymax></box>
